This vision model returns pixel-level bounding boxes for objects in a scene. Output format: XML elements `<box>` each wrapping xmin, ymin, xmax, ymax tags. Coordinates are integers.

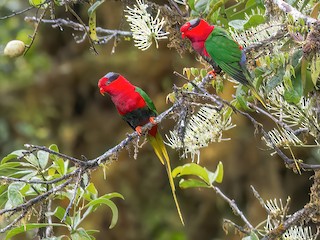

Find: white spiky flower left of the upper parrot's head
<box><xmin>125</xmin><ymin>0</ymin><xmax>169</xmax><ymax>51</ymax></box>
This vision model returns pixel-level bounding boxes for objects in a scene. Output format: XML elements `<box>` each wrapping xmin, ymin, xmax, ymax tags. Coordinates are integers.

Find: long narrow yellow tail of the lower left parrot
<box><xmin>148</xmin><ymin>132</ymin><xmax>184</xmax><ymax>225</ymax></box>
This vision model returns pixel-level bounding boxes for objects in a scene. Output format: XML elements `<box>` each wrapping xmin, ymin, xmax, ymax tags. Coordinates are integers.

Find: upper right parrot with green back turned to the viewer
<box><xmin>180</xmin><ymin>18</ymin><xmax>266</xmax><ymax>107</ymax></box>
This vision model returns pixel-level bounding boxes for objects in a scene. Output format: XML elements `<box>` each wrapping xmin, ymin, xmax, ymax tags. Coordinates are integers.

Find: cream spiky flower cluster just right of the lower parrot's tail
<box><xmin>166</xmin><ymin>105</ymin><xmax>235</xmax><ymax>163</ymax></box>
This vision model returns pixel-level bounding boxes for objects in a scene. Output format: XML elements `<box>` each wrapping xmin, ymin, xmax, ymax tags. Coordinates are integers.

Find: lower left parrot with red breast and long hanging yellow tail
<box><xmin>98</xmin><ymin>72</ymin><xmax>184</xmax><ymax>225</ymax></box>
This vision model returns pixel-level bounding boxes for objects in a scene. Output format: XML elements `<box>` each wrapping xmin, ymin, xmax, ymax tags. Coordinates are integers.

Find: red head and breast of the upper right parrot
<box><xmin>180</xmin><ymin>18</ymin><xmax>214</xmax><ymax>56</ymax></box>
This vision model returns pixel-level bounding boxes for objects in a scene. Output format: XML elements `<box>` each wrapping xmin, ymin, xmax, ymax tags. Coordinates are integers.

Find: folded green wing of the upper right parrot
<box><xmin>205</xmin><ymin>26</ymin><xmax>250</xmax><ymax>85</ymax></box>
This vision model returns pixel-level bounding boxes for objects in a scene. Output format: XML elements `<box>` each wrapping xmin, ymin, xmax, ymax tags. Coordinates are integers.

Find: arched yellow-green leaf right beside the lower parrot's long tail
<box><xmin>172</xmin><ymin>163</ymin><xmax>210</xmax><ymax>185</ymax></box>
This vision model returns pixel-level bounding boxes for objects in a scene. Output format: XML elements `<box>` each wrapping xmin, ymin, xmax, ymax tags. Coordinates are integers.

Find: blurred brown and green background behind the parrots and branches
<box><xmin>0</xmin><ymin>0</ymin><xmax>312</xmax><ymax>240</ymax></box>
